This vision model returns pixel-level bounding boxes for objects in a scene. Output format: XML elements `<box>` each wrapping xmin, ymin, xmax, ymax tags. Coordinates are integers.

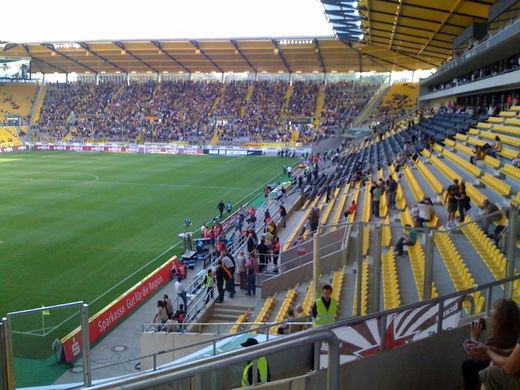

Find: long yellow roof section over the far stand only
<box><xmin>3</xmin><ymin>37</ymin><xmax>442</xmax><ymax>73</ymax></box>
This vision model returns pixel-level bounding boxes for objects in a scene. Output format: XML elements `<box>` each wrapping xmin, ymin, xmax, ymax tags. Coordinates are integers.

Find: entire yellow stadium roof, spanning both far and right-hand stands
<box><xmin>0</xmin><ymin>0</ymin><xmax>495</xmax><ymax>73</ymax></box>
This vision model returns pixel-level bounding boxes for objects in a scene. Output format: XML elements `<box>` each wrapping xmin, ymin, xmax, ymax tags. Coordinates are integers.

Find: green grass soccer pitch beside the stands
<box><xmin>0</xmin><ymin>152</ymin><xmax>291</xmax><ymax>318</ymax></box>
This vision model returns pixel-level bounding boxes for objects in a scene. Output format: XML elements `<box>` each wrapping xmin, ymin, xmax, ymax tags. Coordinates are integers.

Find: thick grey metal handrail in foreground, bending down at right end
<box><xmin>88</xmin><ymin>329</ymin><xmax>340</xmax><ymax>390</ymax></box>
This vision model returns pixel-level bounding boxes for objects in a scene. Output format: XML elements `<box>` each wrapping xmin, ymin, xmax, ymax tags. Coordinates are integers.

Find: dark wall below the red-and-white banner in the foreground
<box><xmin>242</xmin><ymin>326</ymin><xmax>469</xmax><ymax>390</ymax></box>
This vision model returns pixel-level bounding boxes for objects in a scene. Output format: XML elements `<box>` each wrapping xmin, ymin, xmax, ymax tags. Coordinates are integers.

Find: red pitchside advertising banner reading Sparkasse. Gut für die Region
<box><xmin>61</xmin><ymin>256</ymin><xmax>179</xmax><ymax>362</ymax></box>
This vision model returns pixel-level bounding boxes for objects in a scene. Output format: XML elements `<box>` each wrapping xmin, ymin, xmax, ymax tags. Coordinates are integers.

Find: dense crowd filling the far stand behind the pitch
<box><xmin>39</xmin><ymin>80</ymin><xmax>375</xmax><ymax>143</ymax></box>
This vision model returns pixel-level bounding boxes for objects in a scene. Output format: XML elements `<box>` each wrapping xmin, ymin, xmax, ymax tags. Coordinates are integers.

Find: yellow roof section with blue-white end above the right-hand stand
<box><xmin>321</xmin><ymin>0</ymin><xmax>495</xmax><ymax>65</ymax></box>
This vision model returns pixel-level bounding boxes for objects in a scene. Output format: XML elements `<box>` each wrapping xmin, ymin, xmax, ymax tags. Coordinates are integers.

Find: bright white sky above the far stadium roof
<box><xmin>0</xmin><ymin>0</ymin><xmax>333</xmax><ymax>43</ymax></box>
